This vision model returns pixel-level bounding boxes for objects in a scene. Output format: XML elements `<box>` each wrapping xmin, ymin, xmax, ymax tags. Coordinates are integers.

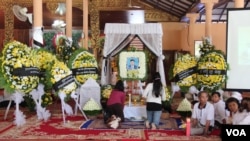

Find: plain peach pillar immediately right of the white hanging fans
<box><xmin>66</xmin><ymin>0</ymin><xmax>72</xmax><ymax>39</ymax></box>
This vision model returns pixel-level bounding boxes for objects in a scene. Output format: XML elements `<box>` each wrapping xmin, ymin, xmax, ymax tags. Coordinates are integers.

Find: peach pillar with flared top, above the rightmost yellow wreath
<box><xmin>201</xmin><ymin>0</ymin><xmax>218</xmax><ymax>38</ymax></box>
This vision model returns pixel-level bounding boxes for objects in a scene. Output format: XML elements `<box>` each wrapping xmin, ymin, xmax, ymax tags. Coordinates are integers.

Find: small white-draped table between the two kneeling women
<box><xmin>123</xmin><ymin>104</ymin><xmax>147</xmax><ymax>121</ymax></box>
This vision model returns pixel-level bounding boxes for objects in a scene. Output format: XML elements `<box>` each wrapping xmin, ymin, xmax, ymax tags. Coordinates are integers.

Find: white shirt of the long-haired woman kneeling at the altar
<box><xmin>142</xmin><ymin>83</ymin><xmax>166</xmax><ymax>104</ymax></box>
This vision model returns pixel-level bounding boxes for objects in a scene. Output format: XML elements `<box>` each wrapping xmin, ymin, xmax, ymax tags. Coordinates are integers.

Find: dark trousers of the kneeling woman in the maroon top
<box><xmin>105</xmin><ymin>103</ymin><xmax>124</xmax><ymax>122</ymax></box>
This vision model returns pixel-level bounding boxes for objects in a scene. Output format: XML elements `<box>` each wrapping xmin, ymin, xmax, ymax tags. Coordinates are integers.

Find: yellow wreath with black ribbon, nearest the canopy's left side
<box><xmin>68</xmin><ymin>49</ymin><xmax>98</xmax><ymax>84</ymax></box>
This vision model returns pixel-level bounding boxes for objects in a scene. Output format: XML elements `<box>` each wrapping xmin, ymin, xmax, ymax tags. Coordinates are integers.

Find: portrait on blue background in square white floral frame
<box><xmin>118</xmin><ymin>51</ymin><xmax>147</xmax><ymax>80</ymax></box>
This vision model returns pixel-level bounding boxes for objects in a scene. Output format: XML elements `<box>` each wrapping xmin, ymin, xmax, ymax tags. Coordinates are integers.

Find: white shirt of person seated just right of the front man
<box><xmin>213</xmin><ymin>100</ymin><xmax>228</xmax><ymax>124</ymax></box>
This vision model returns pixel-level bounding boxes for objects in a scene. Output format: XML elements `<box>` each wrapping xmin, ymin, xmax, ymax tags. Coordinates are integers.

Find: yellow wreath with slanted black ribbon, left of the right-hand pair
<box><xmin>173</xmin><ymin>54</ymin><xmax>197</xmax><ymax>89</ymax></box>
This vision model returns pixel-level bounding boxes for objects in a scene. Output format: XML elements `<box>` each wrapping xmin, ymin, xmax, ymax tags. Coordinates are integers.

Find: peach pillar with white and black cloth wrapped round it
<box><xmin>32</xmin><ymin>0</ymin><xmax>44</xmax><ymax>48</ymax></box>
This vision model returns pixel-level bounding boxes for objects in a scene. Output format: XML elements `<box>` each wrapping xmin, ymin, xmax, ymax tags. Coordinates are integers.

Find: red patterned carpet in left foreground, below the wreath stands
<box><xmin>0</xmin><ymin>114</ymin><xmax>144</xmax><ymax>140</ymax></box>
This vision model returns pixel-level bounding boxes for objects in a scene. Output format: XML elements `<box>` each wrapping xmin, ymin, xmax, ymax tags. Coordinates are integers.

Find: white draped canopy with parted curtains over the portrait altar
<box><xmin>101</xmin><ymin>23</ymin><xmax>166</xmax><ymax>86</ymax></box>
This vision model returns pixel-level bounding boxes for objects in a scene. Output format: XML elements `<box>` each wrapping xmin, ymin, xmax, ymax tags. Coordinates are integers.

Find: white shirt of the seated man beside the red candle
<box><xmin>192</xmin><ymin>102</ymin><xmax>214</xmax><ymax>126</ymax></box>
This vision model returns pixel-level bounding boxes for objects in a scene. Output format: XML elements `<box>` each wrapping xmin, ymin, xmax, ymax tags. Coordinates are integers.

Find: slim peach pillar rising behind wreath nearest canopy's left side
<box><xmin>83</xmin><ymin>0</ymin><xmax>89</xmax><ymax>49</ymax></box>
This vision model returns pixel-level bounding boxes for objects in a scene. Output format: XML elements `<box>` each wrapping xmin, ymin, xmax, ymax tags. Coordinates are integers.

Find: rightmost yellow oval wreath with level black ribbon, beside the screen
<box><xmin>197</xmin><ymin>50</ymin><xmax>228</xmax><ymax>90</ymax></box>
